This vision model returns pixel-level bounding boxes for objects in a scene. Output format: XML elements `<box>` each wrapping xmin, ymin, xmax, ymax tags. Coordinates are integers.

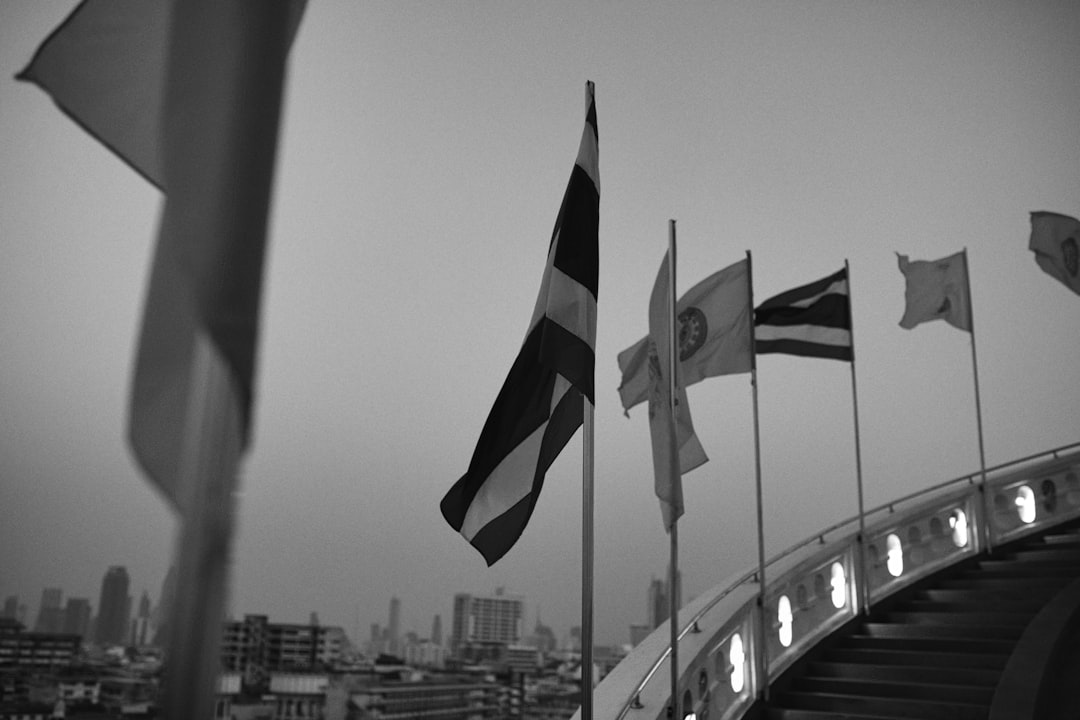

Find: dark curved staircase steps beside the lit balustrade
<box><xmin>764</xmin><ymin>522</ymin><xmax>1080</xmax><ymax>720</ymax></box>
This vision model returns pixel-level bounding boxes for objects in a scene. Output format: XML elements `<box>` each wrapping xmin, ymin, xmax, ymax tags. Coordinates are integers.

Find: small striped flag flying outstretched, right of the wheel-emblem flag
<box><xmin>754</xmin><ymin>268</ymin><xmax>854</xmax><ymax>361</ymax></box>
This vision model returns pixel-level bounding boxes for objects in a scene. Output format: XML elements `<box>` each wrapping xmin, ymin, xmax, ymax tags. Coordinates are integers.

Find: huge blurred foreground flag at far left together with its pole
<box><xmin>21</xmin><ymin>0</ymin><xmax>302</xmax><ymax>718</ymax></box>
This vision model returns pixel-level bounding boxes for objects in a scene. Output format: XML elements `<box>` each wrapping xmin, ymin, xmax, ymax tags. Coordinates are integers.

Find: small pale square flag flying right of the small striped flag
<box><xmin>896</xmin><ymin>250</ymin><xmax>971</xmax><ymax>332</ymax></box>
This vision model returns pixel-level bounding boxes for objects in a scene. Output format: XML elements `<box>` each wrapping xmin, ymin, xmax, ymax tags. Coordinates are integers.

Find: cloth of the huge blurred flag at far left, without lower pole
<box><xmin>18</xmin><ymin>0</ymin><xmax>303</xmax><ymax>511</ymax></box>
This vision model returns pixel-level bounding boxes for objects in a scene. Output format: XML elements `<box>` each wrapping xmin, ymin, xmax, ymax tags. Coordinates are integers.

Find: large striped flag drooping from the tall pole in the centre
<box><xmin>440</xmin><ymin>82</ymin><xmax>600</xmax><ymax>565</ymax></box>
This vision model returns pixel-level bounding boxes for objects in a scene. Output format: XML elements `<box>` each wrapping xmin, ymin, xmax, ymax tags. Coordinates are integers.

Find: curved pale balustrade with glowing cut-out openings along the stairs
<box><xmin>573</xmin><ymin>443</ymin><xmax>1080</xmax><ymax>720</ymax></box>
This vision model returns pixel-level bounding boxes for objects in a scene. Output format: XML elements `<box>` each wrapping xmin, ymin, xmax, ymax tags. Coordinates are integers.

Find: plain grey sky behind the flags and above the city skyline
<box><xmin>0</xmin><ymin>0</ymin><xmax>1080</xmax><ymax>644</ymax></box>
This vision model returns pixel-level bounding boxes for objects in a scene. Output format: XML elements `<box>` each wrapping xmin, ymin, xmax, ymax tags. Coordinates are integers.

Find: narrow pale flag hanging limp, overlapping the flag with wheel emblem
<box><xmin>646</xmin><ymin>253</ymin><xmax>708</xmax><ymax>531</ymax></box>
